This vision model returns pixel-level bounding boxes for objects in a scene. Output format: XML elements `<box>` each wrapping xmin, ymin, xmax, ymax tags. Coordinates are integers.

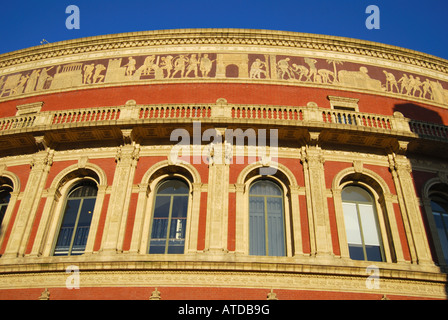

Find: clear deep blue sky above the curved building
<box><xmin>0</xmin><ymin>0</ymin><xmax>448</xmax><ymax>59</ymax></box>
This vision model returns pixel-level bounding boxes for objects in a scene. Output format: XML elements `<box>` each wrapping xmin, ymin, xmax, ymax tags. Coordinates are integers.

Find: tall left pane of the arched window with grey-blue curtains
<box><xmin>249</xmin><ymin>197</ymin><xmax>266</xmax><ymax>256</ymax></box>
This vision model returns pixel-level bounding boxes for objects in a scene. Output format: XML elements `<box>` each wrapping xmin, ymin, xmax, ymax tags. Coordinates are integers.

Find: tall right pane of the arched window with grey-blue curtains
<box><xmin>266</xmin><ymin>197</ymin><xmax>285</xmax><ymax>256</ymax></box>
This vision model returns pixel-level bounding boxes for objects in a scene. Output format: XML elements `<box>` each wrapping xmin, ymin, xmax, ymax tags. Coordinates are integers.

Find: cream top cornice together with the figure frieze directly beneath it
<box><xmin>0</xmin><ymin>29</ymin><xmax>448</xmax><ymax>109</ymax></box>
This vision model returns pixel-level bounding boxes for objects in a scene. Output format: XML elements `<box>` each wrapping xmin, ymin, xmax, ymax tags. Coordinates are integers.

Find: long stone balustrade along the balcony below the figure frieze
<box><xmin>0</xmin><ymin>103</ymin><xmax>448</xmax><ymax>144</ymax></box>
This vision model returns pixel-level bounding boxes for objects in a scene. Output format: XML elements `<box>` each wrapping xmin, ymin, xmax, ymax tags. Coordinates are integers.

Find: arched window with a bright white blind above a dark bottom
<box><xmin>342</xmin><ymin>185</ymin><xmax>384</xmax><ymax>261</ymax></box>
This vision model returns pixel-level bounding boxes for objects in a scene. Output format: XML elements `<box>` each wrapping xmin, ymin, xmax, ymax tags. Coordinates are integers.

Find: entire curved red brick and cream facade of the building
<box><xmin>0</xmin><ymin>29</ymin><xmax>448</xmax><ymax>300</ymax></box>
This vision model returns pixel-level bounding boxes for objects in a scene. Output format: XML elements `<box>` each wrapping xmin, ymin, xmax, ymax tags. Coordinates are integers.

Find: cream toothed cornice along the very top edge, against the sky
<box><xmin>0</xmin><ymin>29</ymin><xmax>448</xmax><ymax>73</ymax></box>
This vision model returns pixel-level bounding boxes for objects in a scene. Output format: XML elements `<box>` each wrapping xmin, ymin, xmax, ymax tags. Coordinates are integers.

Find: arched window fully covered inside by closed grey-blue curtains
<box><xmin>249</xmin><ymin>180</ymin><xmax>286</xmax><ymax>256</ymax></box>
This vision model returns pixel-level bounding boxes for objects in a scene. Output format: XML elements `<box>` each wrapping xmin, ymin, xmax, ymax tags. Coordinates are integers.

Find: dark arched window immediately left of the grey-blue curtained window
<box><xmin>149</xmin><ymin>179</ymin><xmax>189</xmax><ymax>254</ymax></box>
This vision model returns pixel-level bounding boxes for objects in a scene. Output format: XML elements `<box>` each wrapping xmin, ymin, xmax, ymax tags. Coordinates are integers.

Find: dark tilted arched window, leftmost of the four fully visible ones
<box><xmin>54</xmin><ymin>180</ymin><xmax>98</xmax><ymax>256</ymax></box>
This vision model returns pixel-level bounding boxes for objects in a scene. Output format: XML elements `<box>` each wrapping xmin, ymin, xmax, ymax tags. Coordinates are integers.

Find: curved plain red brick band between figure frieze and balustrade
<box><xmin>0</xmin><ymin>83</ymin><xmax>448</xmax><ymax>124</ymax></box>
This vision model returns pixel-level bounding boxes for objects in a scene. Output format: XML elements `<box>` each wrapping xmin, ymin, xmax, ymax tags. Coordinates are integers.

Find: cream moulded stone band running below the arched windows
<box><xmin>0</xmin><ymin>255</ymin><xmax>446</xmax><ymax>299</ymax></box>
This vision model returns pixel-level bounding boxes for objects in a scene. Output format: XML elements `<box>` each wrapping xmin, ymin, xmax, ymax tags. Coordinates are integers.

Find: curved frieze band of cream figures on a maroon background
<box><xmin>0</xmin><ymin>52</ymin><xmax>448</xmax><ymax>105</ymax></box>
